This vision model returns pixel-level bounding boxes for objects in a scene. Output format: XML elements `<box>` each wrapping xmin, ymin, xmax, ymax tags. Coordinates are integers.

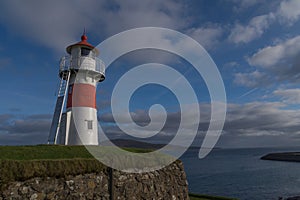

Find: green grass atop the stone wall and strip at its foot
<box><xmin>0</xmin><ymin>145</ymin><xmax>239</xmax><ymax>200</ymax></box>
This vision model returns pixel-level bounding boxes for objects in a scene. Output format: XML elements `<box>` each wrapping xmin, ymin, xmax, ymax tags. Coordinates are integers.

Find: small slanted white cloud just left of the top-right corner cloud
<box><xmin>228</xmin><ymin>13</ymin><xmax>275</xmax><ymax>44</ymax></box>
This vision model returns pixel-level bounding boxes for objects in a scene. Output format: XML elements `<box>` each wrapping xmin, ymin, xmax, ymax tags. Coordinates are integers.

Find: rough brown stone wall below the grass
<box><xmin>0</xmin><ymin>161</ymin><xmax>189</xmax><ymax>200</ymax></box>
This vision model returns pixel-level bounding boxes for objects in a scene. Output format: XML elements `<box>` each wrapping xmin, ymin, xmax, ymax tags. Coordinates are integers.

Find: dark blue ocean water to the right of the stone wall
<box><xmin>180</xmin><ymin>147</ymin><xmax>300</xmax><ymax>200</ymax></box>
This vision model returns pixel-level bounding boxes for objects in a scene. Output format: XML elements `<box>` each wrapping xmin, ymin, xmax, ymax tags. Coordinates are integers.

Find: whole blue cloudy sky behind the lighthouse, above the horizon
<box><xmin>0</xmin><ymin>0</ymin><xmax>300</xmax><ymax>148</ymax></box>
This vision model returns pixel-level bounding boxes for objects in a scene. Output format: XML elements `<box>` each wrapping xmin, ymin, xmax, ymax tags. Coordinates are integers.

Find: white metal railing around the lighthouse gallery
<box><xmin>59</xmin><ymin>56</ymin><xmax>105</xmax><ymax>75</ymax></box>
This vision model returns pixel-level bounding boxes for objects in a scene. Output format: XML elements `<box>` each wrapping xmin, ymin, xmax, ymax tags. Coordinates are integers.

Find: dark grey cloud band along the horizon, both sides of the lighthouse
<box><xmin>0</xmin><ymin>102</ymin><xmax>300</xmax><ymax>147</ymax></box>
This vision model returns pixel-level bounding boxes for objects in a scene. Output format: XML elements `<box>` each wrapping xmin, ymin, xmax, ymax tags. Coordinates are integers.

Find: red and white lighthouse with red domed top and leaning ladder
<box><xmin>48</xmin><ymin>31</ymin><xmax>105</xmax><ymax>145</ymax></box>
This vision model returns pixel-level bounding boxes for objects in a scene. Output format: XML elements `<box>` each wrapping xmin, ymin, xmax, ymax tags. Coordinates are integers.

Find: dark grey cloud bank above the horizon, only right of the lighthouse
<box><xmin>99</xmin><ymin>102</ymin><xmax>300</xmax><ymax>147</ymax></box>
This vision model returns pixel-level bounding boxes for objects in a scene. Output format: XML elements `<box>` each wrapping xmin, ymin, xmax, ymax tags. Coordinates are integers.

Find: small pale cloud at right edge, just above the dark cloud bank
<box><xmin>273</xmin><ymin>88</ymin><xmax>300</xmax><ymax>104</ymax></box>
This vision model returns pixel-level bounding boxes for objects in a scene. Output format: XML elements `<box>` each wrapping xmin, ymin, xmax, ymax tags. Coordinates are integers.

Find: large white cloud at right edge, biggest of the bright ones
<box><xmin>235</xmin><ymin>36</ymin><xmax>300</xmax><ymax>87</ymax></box>
